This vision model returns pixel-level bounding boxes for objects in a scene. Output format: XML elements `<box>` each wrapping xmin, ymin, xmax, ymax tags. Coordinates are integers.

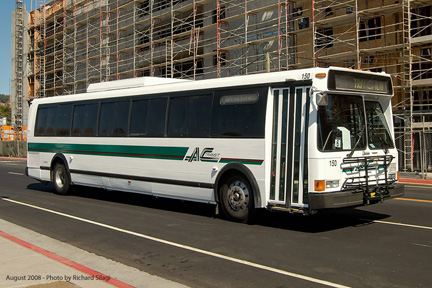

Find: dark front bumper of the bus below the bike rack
<box><xmin>309</xmin><ymin>183</ymin><xmax>404</xmax><ymax>210</ymax></box>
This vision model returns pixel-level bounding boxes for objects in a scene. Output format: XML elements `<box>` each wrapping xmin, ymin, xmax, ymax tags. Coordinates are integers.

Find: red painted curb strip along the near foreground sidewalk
<box><xmin>0</xmin><ymin>230</ymin><xmax>135</xmax><ymax>288</ymax></box>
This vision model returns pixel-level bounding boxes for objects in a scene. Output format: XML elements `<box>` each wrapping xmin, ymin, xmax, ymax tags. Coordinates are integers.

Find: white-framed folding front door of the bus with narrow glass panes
<box><xmin>269</xmin><ymin>87</ymin><xmax>310</xmax><ymax>209</ymax></box>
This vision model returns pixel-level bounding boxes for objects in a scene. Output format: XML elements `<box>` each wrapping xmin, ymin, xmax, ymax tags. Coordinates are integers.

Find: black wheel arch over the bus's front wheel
<box><xmin>214</xmin><ymin>163</ymin><xmax>261</xmax><ymax>208</ymax></box>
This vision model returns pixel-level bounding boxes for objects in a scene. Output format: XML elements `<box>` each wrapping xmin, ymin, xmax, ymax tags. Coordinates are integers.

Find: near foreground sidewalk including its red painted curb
<box><xmin>0</xmin><ymin>219</ymin><xmax>186</xmax><ymax>288</ymax></box>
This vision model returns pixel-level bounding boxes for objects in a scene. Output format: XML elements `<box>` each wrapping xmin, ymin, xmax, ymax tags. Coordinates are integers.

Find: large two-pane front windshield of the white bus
<box><xmin>318</xmin><ymin>95</ymin><xmax>394</xmax><ymax>151</ymax></box>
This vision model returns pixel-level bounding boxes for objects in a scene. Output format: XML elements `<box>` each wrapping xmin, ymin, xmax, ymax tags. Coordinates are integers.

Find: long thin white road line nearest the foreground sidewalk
<box><xmin>1</xmin><ymin>198</ymin><xmax>349</xmax><ymax>288</ymax></box>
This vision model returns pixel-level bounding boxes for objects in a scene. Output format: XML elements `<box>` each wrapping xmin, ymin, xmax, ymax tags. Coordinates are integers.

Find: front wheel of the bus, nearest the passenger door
<box><xmin>220</xmin><ymin>175</ymin><xmax>253</xmax><ymax>222</ymax></box>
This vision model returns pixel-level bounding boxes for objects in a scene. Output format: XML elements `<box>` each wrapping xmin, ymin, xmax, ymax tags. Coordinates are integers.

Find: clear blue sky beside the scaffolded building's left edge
<box><xmin>0</xmin><ymin>0</ymin><xmax>36</xmax><ymax>95</ymax></box>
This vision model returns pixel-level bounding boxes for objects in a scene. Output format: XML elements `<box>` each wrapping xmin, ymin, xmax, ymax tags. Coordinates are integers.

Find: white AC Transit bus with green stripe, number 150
<box><xmin>27</xmin><ymin>67</ymin><xmax>403</xmax><ymax>221</ymax></box>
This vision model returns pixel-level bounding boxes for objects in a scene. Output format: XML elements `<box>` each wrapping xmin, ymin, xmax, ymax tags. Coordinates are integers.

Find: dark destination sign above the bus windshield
<box><xmin>328</xmin><ymin>70</ymin><xmax>393</xmax><ymax>95</ymax></box>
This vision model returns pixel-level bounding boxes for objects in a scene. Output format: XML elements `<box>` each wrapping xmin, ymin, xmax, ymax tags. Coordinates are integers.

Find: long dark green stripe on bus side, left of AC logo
<box><xmin>28</xmin><ymin>143</ymin><xmax>189</xmax><ymax>160</ymax></box>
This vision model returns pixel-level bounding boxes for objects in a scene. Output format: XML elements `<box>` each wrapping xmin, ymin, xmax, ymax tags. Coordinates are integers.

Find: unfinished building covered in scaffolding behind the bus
<box><xmin>11</xmin><ymin>0</ymin><xmax>432</xmax><ymax>172</ymax></box>
